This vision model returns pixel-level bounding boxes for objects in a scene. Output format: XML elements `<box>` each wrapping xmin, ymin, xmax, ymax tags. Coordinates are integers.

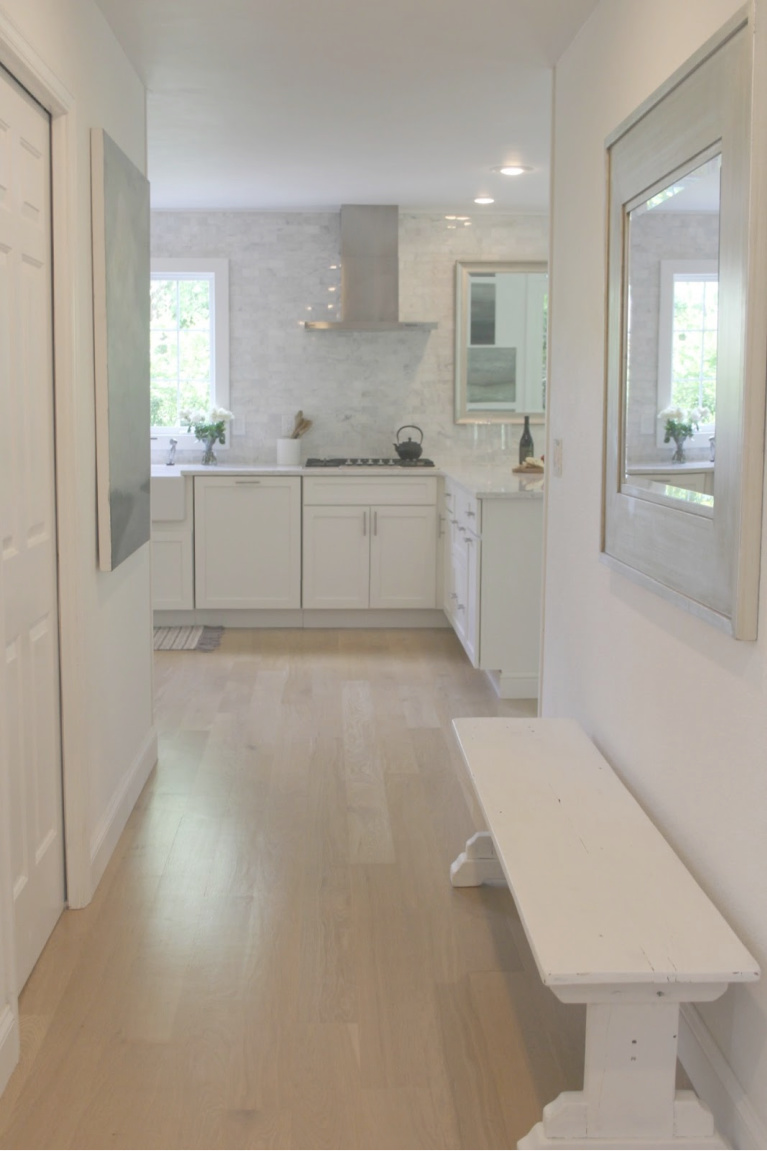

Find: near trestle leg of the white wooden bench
<box><xmin>517</xmin><ymin>1003</ymin><xmax>728</xmax><ymax>1151</ymax></box>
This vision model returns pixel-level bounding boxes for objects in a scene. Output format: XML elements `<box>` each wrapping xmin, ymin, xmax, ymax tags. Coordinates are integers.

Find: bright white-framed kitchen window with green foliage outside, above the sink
<box><xmin>150</xmin><ymin>259</ymin><xmax>229</xmax><ymax>447</ymax></box>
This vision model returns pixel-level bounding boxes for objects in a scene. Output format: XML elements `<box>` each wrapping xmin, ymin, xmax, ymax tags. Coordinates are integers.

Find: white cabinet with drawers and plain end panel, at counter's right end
<box><xmin>442</xmin><ymin>478</ymin><xmax>542</xmax><ymax>699</ymax></box>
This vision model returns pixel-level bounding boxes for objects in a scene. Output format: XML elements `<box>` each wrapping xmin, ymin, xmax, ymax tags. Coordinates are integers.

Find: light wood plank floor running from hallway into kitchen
<box><xmin>0</xmin><ymin>631</ymin><xmax>583</xmax><ymax>1148</ymax></box>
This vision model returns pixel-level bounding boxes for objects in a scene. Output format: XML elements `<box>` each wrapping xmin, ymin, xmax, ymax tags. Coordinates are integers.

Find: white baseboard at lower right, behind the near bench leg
<box><xmin>679</xmin><ymin>1004</ymin><xmax>767</xmax><ymax>1148</ymax></box>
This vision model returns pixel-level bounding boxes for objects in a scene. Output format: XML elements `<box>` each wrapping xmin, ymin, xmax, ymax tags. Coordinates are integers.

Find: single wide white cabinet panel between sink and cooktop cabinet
<box><xmin>195</xmin><ymin>475</ymin><xmax>301</xmax><ymax>609</ymax></box>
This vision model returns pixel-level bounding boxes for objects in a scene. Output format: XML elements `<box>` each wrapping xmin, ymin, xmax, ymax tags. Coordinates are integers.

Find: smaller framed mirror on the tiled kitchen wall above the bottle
<box><xmin>455</xmin><ymin>260</ymin><xmax>548</xmax><ymax>424</ymax></box>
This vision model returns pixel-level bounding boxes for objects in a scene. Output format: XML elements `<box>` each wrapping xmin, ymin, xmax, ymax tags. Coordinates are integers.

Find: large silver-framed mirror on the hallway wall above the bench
<box><xmin>602</xmin><ymin>14</ymin><xmax>767</xmax><ymax>639</ymax></box>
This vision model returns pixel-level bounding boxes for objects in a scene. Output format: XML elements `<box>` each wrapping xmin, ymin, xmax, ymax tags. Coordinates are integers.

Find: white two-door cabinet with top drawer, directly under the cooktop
<box><xmin>303</xmin><ymin>477</ymin><xmax>436</xmax><ymax>609</ymax></box>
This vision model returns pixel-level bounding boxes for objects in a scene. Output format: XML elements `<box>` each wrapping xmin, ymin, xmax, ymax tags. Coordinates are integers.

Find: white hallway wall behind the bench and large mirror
<box><xmin>541</xmin><ymin>0</ymin><xmax>767</xmax><ymax>1146</ymax></box>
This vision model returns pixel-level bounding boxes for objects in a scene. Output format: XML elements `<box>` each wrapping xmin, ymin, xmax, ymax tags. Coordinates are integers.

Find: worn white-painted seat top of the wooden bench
<box><xmin>454</xmin><ymin>718</ymin><xmax>759</xmax><ymax>986</ymax></box>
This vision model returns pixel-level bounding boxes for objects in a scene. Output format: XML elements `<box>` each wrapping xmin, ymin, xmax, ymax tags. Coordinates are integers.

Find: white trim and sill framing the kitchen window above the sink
<box><xmin>150</xmin><ymin>257</ymin><xmax>231</xmax><ymax>451</ymax></box>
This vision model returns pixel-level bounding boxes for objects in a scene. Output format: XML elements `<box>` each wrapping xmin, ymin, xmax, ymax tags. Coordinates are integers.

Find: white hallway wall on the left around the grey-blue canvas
<box><xmin>0</xmin><ymin>0</ymin><xmax>155</xmax><ymax>1074</ymax></box>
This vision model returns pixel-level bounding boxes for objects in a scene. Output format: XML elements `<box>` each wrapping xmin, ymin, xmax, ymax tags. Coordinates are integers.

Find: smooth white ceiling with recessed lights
<box><xmin>96</xmin><ymin>0</ymin><xmax>598</xmax><ymax>213</ymax></box>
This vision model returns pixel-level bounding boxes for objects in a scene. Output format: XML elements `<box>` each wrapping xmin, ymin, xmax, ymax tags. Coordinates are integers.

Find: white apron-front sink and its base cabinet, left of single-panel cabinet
<box><xmin>151</xmin><ymin>475</ymin><xmax>195</xmax><ymax>611</ymax></box>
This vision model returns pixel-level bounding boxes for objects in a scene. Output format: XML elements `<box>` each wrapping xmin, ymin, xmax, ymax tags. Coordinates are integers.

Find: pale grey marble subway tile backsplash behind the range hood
<box><xmin>152</xmin><ymin>212</ymin><xmax>548</xmax><ymax>464</ymax></box>
